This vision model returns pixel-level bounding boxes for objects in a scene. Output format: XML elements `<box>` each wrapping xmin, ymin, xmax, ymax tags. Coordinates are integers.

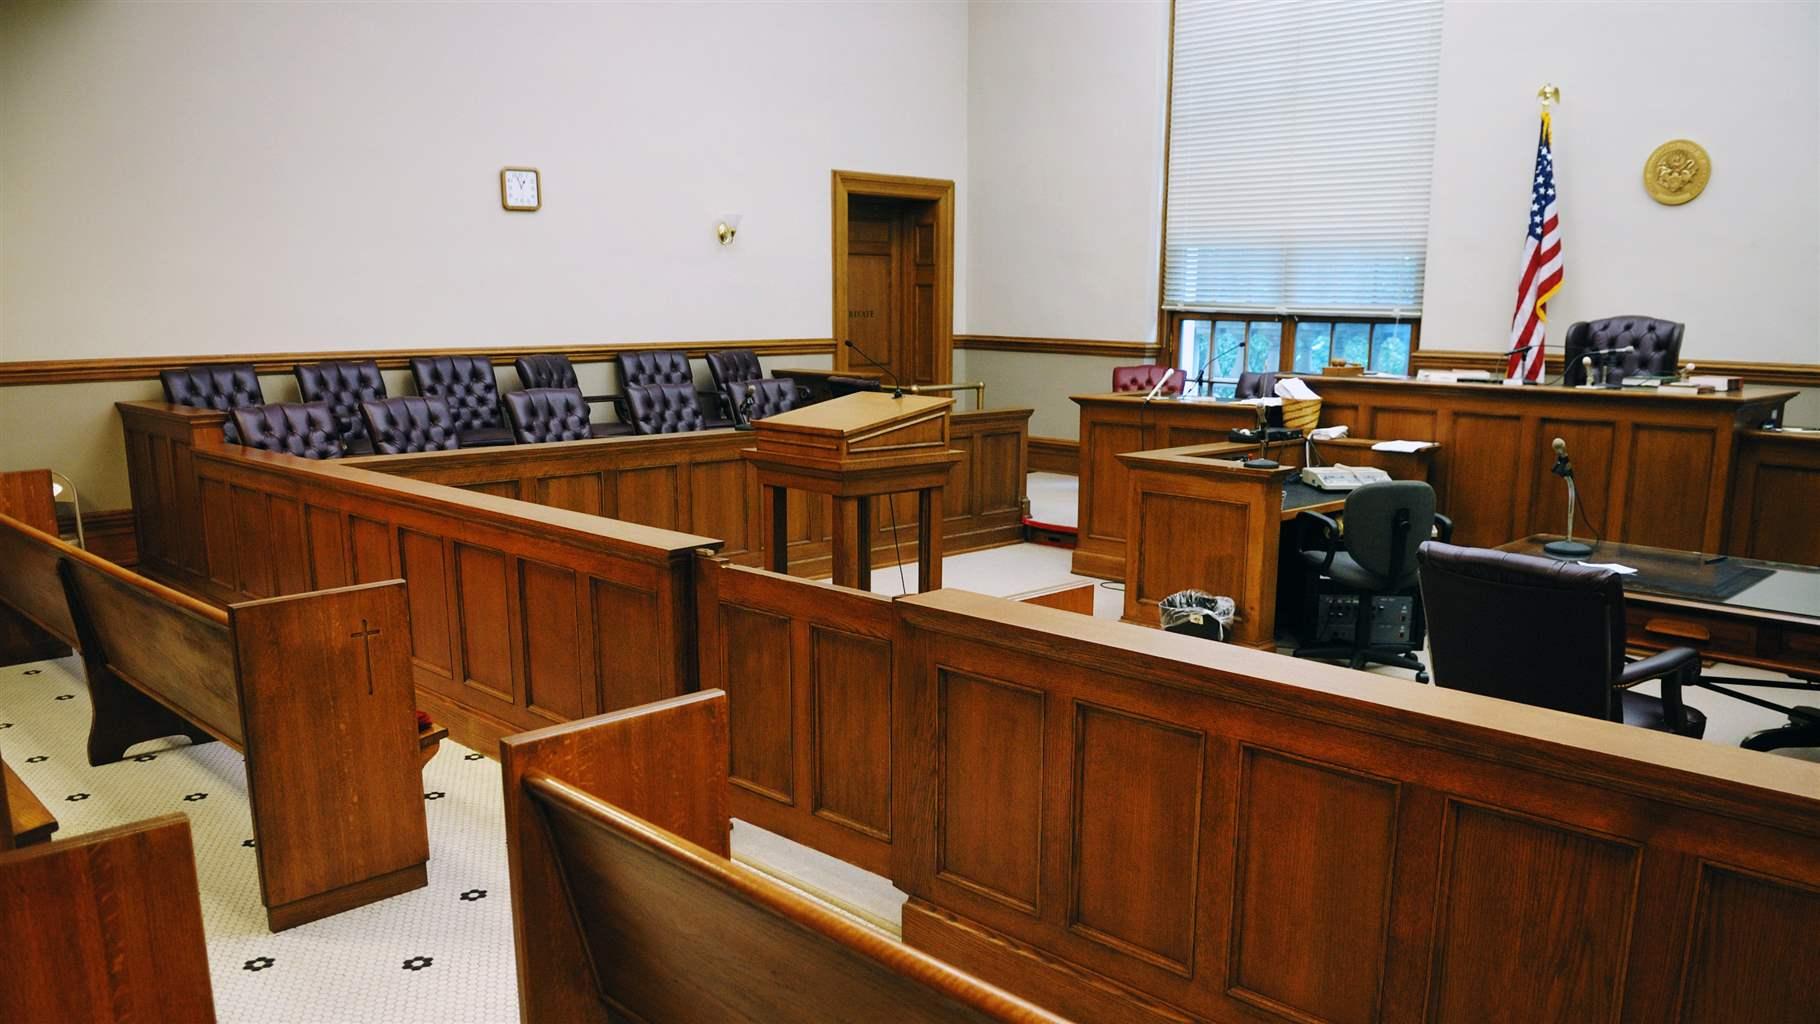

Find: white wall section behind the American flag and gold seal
<box><xmin>1421</xmin><ymin>0</ymin><xmax>1820</xmax><ymax>364</ymax></box>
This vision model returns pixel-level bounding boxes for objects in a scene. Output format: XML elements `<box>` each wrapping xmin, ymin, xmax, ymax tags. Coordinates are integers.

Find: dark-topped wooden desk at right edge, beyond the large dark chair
<box><xmin>1502</xmin><ymin>535</ymin><xmax>1820</xmax><ymax>682</ymax></box>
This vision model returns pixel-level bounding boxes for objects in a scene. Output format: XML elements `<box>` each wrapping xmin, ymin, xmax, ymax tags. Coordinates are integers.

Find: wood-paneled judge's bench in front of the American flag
<box><xmin>1307</xmin><ymin>376</ymin><xmax>1795</xmax><ymax>551</ymax></box>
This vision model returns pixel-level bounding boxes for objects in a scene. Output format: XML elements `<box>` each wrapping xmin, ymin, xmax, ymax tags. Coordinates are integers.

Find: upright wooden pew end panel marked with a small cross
<box><xmin>228</xmin><ymin>580</ymin><xmax>430</xmax><ymax>931</ymax></box>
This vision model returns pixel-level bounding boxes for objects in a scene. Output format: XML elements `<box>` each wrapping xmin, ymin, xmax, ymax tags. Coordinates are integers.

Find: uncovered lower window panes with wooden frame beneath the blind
<box><xmin>1170</xmin><ymin>313</ymin><xmax>1420</xmax><ymax>398</ymax></box>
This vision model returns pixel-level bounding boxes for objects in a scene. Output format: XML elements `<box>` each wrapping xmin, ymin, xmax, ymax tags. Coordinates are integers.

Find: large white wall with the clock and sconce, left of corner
<box><xmin>0</xmin><ymin>2</ymin><xmax>968</xmax><ymax>360</ymax></box>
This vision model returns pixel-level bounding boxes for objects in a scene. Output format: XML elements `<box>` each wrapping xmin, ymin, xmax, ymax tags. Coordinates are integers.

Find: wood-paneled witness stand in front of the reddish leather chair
<box><xmin>1072</xmin><ymin>395</ymin><xmax>1258</xmax><ymax>580</ymax></box>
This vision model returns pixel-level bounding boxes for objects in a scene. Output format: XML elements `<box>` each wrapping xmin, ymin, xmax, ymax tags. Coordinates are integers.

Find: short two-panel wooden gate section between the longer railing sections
<box><xmin>695</xmin><ymin>557</ymin><xmax>894</xmax><ymax>875</ymax></box>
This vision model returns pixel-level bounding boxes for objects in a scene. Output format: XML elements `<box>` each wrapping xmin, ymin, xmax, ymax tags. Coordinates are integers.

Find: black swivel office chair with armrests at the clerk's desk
<box><xmin>1296</xmin><ymin>480</ymin><xmax>1454</xmax><ymax>682</ymax></box>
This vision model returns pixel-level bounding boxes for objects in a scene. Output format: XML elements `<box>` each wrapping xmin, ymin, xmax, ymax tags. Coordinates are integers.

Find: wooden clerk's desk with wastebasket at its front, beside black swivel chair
<box><xmin>1117</xmin><ymin>438</ymin><xmax>1440</xmax><ymax>651</ymax></box>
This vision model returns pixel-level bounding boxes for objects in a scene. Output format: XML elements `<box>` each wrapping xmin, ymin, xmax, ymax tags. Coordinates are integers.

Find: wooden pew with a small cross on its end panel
<box><xmin>0</xmin><ymin>515</ymin><xmax>430</xmax><ymax>931</ymax></box>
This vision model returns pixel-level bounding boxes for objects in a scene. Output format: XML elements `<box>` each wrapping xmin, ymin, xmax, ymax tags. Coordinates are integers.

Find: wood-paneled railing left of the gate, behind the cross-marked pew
<box><xmin>177</xmin><ymin>446</ymin><xmax>717</xmax><ymax>749</ymax></box>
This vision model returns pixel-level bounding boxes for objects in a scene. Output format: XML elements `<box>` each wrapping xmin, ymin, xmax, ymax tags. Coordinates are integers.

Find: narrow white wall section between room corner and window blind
<box><xmin>961</xmin><ymin>0</ymin><xmax>1168</xmax><ymax>343</ymax></box>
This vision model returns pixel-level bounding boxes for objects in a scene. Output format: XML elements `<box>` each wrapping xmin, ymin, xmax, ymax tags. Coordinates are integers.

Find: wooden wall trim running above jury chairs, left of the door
<box><xmin>0</xmin><ymin>338</ymin><xmax>834</xmax><ymax>387</ymax></box>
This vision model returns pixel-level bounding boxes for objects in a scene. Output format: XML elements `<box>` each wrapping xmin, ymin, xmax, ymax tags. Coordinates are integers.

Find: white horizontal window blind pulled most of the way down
<box><xmin>1163</xmin><ymin>0</ymin><xmax>1441</xmax><ymax>316</ymax></box>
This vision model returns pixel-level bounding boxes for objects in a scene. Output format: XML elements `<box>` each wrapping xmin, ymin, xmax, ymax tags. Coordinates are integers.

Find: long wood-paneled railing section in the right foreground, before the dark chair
<box><xmin>892</xmin><ymin>591</ymin><xmax>1820</xmax><ymax>1024</ymax></box>
